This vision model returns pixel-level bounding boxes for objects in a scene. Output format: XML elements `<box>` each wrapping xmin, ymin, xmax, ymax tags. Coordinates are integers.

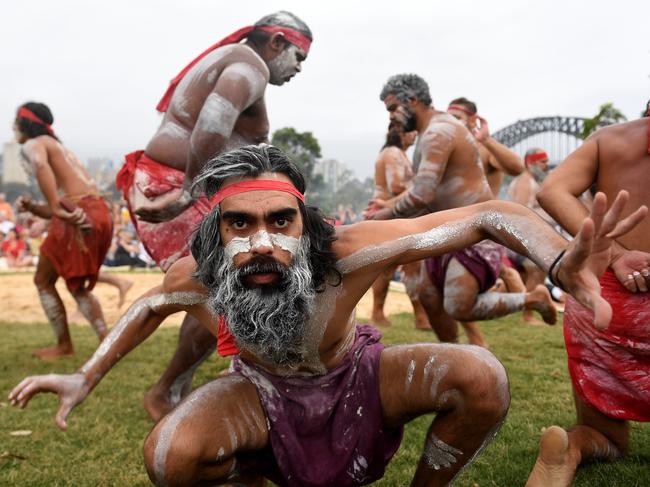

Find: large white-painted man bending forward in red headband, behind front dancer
<box><xmin>117</xmin><ymin>11</ymin><xmax>312</xmax><ymax>420</ymax></box>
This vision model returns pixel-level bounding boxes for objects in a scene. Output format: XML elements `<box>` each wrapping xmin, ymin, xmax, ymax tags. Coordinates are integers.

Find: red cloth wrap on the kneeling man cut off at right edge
<box><xmin>564</xmin><ymin>270</ymin><xmax>650</xmax><ymax>421</ymax></box>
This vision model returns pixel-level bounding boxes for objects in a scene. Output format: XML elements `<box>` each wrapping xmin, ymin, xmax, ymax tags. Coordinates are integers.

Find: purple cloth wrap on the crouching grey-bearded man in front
<box><xmin>233</xmin><ymin>325</ymin><xmax>403</xmax><ymax>487</ymax></box>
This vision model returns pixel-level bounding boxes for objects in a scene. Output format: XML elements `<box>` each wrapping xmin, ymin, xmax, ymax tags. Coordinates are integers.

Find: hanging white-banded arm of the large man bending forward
<box><xmin>136</xmin><ymin>62</ymin><xmax>267</xmax><ymax>223</ymax></box>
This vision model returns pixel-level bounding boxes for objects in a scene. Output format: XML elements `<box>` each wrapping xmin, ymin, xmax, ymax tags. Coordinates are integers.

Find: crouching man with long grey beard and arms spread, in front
<box><xmin>10</xmin><ymin>146</ymin><xmax>647</xmax><ymax>487</ymax></box>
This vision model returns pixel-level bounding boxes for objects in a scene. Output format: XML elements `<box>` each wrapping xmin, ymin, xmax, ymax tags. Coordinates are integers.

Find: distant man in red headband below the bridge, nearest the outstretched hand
<box><xmin>507</xmin><ymin>147</ymin><xmax>555</xmax><ymax>325</ymax></box>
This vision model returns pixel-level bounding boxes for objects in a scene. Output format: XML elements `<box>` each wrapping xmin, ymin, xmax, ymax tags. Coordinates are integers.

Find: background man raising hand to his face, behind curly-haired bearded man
<box><xmin>447</xmin><ymin>97</ymin><xmax>524</xmax><ymax>198</ymax></box>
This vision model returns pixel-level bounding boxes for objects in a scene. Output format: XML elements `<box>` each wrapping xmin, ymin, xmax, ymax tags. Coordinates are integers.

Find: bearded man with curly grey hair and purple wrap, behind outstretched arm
<box><xmin>367</xmin><ymin>74</ymin><xmax>556</xmax><ymax>343</ymax></box>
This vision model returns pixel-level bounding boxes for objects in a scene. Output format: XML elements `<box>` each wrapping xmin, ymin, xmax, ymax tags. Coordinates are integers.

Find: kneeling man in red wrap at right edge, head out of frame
<box><xmin>527</xmin><ymin>107</ymin><xmax>650</xmax><ymax>487</ymax></box>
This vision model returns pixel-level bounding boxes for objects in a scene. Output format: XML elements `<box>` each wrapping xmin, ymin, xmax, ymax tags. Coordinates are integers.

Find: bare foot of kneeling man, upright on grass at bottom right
<box><xmin>526</xmin><ymin>426</ymin><xmax>577</xmax><ymax>487</ymax></box>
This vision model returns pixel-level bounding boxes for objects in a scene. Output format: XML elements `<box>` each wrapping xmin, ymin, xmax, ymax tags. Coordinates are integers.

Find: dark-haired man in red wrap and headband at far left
<box><xmin>14</xmin><ymin>102</ymin><xmax>113</xmax><ymax>359</ymax></box>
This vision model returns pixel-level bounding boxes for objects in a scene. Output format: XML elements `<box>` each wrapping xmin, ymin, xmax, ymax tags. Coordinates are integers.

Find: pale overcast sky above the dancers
<box><xmin>0</xmin><ymin>0</ymin><xmax>650</xmax><ymax>177</ymax></box>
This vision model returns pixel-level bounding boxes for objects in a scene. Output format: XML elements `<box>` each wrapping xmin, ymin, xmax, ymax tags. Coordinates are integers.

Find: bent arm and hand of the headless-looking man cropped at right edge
<box><xmin>537</xmin><ymin>137</ymin><xmax>650</xmax><ymax>292</ymax></box>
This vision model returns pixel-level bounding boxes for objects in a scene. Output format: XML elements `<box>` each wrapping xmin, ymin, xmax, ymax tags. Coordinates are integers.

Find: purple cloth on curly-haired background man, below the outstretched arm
<box><xmin>425</xmin><ymin>240</ymin><xmax>504</xmax><ymax>293</ymax></box>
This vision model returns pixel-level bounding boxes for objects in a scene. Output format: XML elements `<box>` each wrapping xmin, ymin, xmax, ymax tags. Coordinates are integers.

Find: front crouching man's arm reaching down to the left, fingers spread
<box><xmin>9</xmin><ymin>269</ymin><xmax>204</xmax><ymax>430</ymax></box>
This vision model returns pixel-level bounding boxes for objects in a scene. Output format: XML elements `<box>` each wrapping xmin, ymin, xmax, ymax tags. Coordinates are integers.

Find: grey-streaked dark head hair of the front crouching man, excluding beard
<box><xmin>191</xmin><ymin>144</ymin><xmax>341</xmax><ymax>292</ymax></box>
